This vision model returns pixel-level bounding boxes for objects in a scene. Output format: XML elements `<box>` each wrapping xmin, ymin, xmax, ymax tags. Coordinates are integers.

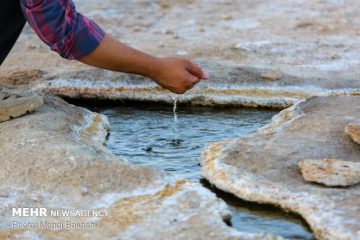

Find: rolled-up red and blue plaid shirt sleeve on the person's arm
<box><xmin>20</xmin><ymin>0</ymin><xmax>105</xmax><ymax>59</ymax></box>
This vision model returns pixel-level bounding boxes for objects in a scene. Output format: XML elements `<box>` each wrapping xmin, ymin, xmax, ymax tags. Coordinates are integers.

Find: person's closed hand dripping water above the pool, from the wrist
<box><xmin>151</xmin><ymin>57</ymin><xmax>209</xmax><ymax>94</ymax></box>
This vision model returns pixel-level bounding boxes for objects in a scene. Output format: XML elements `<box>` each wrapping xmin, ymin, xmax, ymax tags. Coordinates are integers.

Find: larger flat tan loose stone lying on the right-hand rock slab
<box><xmin>299</xmin><ymin>159</ymin><xmax>360</xmax><ymax>187</ymax></box>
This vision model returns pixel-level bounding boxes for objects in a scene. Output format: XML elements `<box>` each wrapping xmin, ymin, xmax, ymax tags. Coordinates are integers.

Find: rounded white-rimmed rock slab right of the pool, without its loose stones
<box><xmin>201</xmin><ymin>96</ymin><xmax>360</xmax><ymax>240</ymax></box>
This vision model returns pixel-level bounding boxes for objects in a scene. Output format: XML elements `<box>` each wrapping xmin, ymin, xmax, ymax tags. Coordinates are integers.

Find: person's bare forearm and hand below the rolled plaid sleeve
<box><xmin>79</xmin><ymin>35</ymin><xmax>208</xmax><ymax>93</ymax></box>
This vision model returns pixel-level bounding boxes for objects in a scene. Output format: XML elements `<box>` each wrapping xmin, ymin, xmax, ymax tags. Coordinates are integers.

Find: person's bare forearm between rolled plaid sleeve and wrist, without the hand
<box><xmin>78</xmin><ymin>34</ymin><xmax>161</xmax><ymax>78</ymax></box>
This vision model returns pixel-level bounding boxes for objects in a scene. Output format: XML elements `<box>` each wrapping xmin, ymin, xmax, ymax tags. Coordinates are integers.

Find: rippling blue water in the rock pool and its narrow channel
<box><xmin>78</xmin><ymin>104</ymin><xmax>313</xmax><ymax>239</ymax></box>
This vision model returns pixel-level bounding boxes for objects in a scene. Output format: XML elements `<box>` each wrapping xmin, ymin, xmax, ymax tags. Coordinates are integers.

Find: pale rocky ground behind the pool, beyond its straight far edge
<box><xmin>0</xmin><ymin>0</ymin><xmax>360</xmax><ymax>108</ymax></box>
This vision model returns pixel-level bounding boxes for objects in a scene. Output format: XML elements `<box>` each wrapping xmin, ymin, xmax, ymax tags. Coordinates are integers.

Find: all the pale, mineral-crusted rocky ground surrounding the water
<box><xmin>0</xmin><ymin>0</ymin><xmax>360</xmax><ymax>239</ymax></box>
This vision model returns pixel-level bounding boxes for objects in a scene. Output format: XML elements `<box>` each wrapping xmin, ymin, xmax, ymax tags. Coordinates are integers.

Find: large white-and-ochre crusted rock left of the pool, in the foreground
<box><xmin>0</xmin><ymin>96</ymin><xmax>280</xmax><ymax>240</ymax></box>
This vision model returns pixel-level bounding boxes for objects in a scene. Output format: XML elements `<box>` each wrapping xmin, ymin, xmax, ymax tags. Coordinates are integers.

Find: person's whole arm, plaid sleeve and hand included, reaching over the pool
<box><xmin>21</xmin><ymin>0</ymin><xmax>208</xmax><ymax>93</ymax></box>
